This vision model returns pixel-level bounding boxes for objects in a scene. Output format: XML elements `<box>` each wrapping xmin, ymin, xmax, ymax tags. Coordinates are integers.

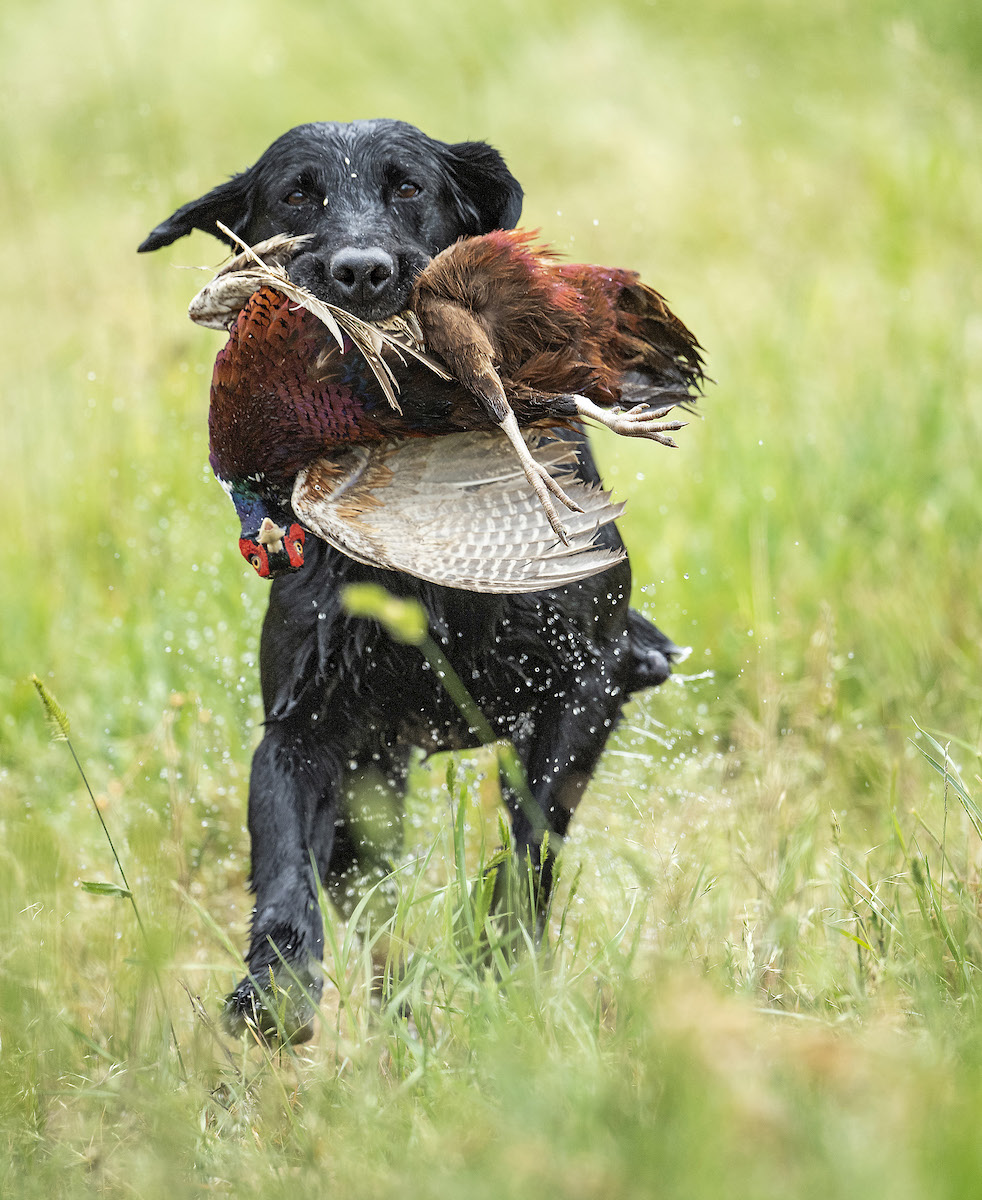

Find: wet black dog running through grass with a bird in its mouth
<box><xmin>139</xmin><ymin>120</ymin><xmax>676</xmax><ymax>1040</ymax></box>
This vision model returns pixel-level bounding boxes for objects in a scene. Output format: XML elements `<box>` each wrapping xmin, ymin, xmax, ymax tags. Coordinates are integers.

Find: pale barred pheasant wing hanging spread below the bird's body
<box><xmin>293</xmin><ymin>431</ymin><xmax>624</xmax><ymax>593</ymax></box>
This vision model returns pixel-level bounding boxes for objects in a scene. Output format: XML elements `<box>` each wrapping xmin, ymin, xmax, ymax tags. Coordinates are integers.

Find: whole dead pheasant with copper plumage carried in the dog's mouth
<box><xmin>190</xmin><ymin>232</ymin><xmax>702</xmax><ymax>592</ymax></box>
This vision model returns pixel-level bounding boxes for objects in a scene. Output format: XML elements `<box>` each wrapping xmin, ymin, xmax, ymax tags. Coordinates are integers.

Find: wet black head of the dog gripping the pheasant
<box><xmin>139</xmin><ymin>120</ymin><xmax>522</xmax><ymax>320</ymax></box>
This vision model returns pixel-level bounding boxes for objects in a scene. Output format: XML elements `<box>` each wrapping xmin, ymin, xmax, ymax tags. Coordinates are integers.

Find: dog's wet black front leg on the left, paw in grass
<box><xmin>224</xmin><ymin>715</ymin><xmax>340</xmax><ymax>1042</ymax></box>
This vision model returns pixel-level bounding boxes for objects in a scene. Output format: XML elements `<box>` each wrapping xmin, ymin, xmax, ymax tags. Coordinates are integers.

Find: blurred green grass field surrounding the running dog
<box><xmin>0</xmin><ymin>0</ymin><xmax>982</xmax><ymax>1200</ymax></box>
